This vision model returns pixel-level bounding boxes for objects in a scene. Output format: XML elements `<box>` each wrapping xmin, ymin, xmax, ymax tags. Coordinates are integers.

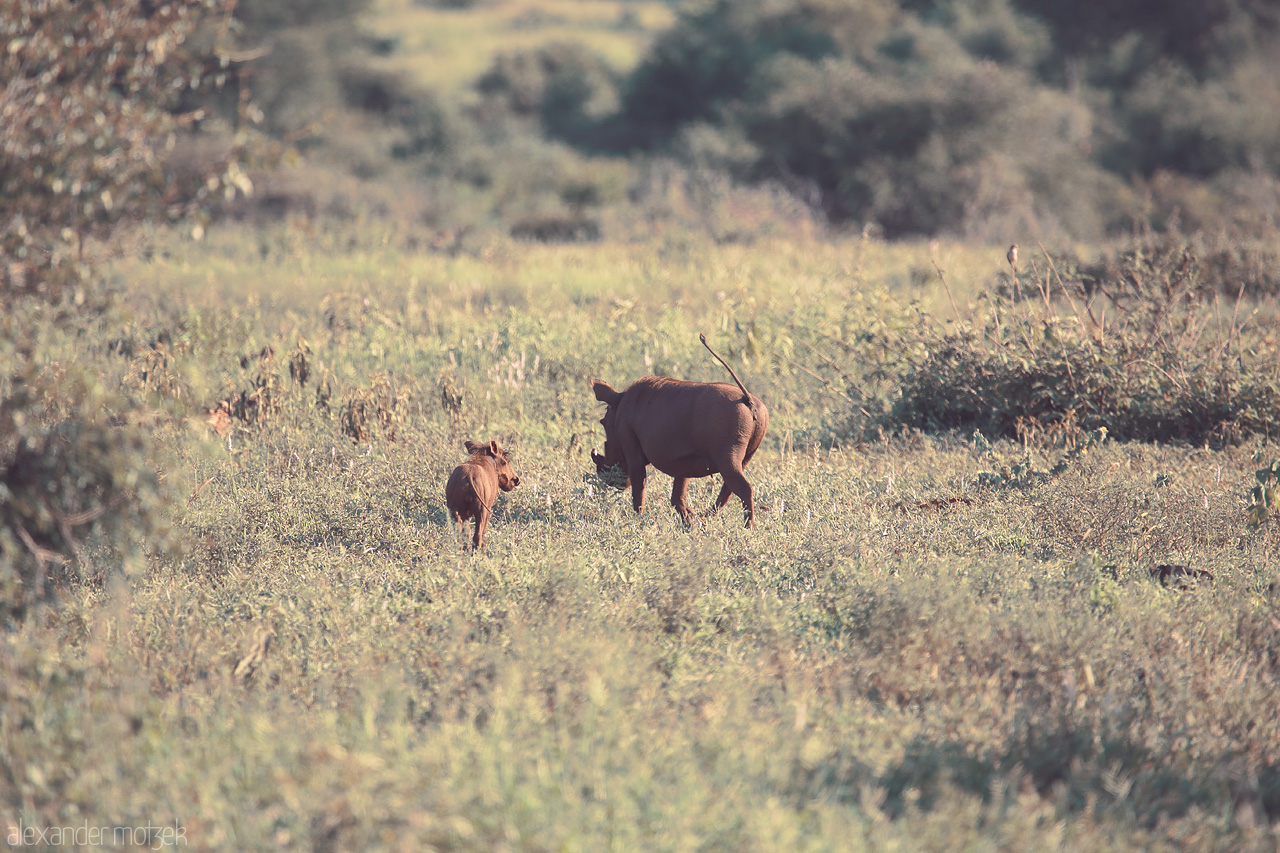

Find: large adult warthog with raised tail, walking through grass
<box><xmin>591</xmin><ymin>334</ymin><xmax>769</xmax><ymax>528</ymax></box>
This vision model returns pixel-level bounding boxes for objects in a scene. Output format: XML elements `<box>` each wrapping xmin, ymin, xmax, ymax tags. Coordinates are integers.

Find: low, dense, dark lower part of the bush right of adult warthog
<box><xmin>886</xmin><ymin>327</ymin><xmax>1280</xmax><ymax>444</ymax></box>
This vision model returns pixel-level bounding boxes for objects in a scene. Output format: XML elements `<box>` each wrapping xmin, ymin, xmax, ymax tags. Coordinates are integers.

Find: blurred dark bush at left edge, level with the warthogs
<box><xmin>0</xmin><ymin>361</ymin><xmax>173</xmax><ymax>620</ymax></box>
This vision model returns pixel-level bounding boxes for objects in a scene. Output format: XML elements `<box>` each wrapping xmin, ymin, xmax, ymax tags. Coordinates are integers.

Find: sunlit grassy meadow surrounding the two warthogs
<box><xmin>0</xmin><ymin>222</ymin><xmax>1280</xmax><ymax>850</ymax></box>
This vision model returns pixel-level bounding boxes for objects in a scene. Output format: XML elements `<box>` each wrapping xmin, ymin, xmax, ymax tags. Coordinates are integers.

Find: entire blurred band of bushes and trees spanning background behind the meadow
<box><xmin>237</xmin><ymin>0</ymin><xmax>1280</xmax><ymax>241</ymax></box>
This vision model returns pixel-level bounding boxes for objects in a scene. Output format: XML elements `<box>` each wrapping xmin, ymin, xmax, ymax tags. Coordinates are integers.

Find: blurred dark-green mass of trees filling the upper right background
<box><xmin>604</xmin><ymin>0</ymin><xmax>1280</xmax><ymax>240</ymax></box>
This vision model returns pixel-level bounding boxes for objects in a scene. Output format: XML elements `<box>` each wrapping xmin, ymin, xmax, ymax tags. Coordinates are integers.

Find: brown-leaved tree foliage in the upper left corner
<box><xmin>0</xmin><ymin>0</ymin><xmax>241</xmax><ymax>300</ymax></box>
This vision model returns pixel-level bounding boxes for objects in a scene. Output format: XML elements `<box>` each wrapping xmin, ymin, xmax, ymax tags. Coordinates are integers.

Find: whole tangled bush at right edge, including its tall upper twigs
<box><xmin>884</xmin><ymin>235</ymin><xmax>1280</xmax><ymax>444</ymax></box>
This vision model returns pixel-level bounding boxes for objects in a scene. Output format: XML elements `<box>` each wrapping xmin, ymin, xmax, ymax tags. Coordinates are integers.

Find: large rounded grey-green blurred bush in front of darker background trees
<box><xmin>741</xmin><ymin>48</ymin><xmax>1106</xmax><ymax>238</ymax></box>
